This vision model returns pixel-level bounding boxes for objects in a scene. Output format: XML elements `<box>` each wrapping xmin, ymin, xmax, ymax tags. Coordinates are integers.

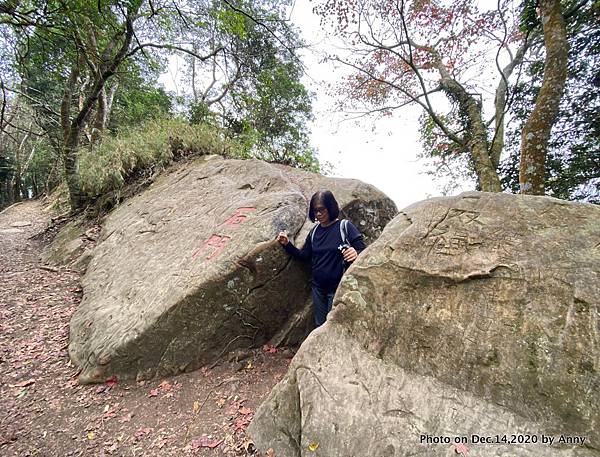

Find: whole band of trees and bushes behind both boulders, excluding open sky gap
<box><xmin>0</xmin><ymin>0</ymin><xmax>600</xmax><ymax>213</ymax></box>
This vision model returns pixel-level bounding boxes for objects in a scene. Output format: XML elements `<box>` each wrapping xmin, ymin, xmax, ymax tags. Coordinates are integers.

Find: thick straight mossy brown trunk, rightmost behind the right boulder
<box><xmin>519</xmin><ymin>0</ymin><xmax>569</xmax><ymax>195</ymax></box>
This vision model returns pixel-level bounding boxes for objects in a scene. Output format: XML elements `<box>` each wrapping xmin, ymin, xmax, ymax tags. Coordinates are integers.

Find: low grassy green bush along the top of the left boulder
<box><xmin>78</xmin><ymin>119</ymin><xmax>244</xmax><ymax>198</ymax></box>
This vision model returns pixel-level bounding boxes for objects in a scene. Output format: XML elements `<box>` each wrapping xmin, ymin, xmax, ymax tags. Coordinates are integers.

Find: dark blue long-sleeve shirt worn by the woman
<box><xmin>284</xmin><ymin>221</ymin><xmax>365</xmax><ymax>291</ymax></box>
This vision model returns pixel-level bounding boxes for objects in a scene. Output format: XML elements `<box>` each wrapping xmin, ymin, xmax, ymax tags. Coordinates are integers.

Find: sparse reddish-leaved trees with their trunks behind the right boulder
<box><xmin>315</xmin><ymin>0</ymin><xmax>594</xmax><ymax>194</ymax></box>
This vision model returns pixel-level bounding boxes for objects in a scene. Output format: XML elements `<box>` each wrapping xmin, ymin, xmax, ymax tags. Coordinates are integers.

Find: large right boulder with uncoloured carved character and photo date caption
<box><xmin>249</xmin><ymin>192</ymin><xmax>600</xmax><ymax>457</ymax></box>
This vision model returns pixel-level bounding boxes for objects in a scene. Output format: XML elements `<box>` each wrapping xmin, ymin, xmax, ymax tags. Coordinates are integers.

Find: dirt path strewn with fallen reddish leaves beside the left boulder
<box><xmin>0</xmin><ymin>202</ymin><xmax>291</xmax><ymax>457</ymax></box>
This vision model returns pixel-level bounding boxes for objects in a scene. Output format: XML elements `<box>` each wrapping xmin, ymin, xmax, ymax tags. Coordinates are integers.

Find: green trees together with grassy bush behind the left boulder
<box><xmin>0</xmin><ymin>0</ymin><xmax>318</xmax><ymax>212</ymax></box>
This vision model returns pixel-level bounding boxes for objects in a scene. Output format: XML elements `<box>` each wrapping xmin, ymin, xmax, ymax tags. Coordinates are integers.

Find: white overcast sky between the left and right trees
<box><xmin>290</xmin><ymin>0</ymin><xmax>472</xmax><ymax>209</ymax></box>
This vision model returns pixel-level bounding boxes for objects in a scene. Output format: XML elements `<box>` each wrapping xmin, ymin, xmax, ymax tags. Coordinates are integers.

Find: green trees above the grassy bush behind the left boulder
<box><xmin>0</xmin><ymin>0</ymin><xmax>318</xmax><ymax>210</ymax></box>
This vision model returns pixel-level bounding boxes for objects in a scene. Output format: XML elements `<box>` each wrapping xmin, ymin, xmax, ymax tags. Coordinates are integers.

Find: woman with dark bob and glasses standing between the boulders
<box><xmin>277</xmin><ymin>190</ymin><xmax>365</xmax><ymax>327</ymax></box>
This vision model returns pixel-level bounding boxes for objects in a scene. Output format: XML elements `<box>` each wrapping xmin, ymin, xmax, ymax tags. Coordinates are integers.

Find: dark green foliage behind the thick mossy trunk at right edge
<box><xmin>501</xmin><ymin>1</ymin><xmax>600</xmax><ymax>203</ymax></box>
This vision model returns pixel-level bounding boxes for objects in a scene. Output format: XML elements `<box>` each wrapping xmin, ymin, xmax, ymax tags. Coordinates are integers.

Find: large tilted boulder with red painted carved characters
<box><xmin>69</xmin><ymin>156</ymin><xmax>397</xmax><ymax>383</ymax></box>
